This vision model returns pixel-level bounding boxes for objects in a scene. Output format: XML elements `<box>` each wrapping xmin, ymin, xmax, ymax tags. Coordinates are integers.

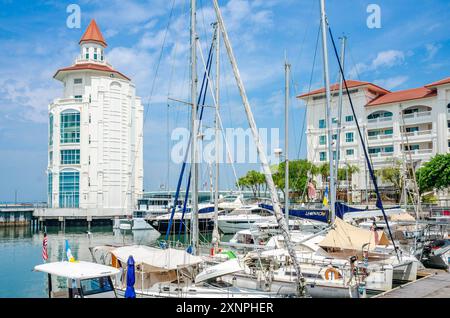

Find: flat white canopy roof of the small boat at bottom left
<box><xmin>34</xmin><ymin>261</ymin><xmax>120</xmax><ymax>279</ymax></box>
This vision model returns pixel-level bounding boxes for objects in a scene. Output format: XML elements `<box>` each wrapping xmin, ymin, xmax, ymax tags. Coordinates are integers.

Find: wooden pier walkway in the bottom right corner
<box><xmin>373</xmin><ymin>270</ymin><xmax>450</xmax><ymax>298</ymax></box>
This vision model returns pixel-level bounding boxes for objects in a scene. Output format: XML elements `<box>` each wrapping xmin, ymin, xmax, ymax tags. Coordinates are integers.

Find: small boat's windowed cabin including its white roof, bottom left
<box><xmin>34</xmin><ymin>261</ymin><xmax>120</xmax><ymax>298</ymax></box>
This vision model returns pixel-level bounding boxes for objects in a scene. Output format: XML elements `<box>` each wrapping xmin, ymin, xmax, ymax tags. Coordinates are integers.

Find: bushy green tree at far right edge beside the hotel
<box><xmin>416</xmin><ymin>154</ymin><xmax>450</xmax><ymax>193</ymax></box>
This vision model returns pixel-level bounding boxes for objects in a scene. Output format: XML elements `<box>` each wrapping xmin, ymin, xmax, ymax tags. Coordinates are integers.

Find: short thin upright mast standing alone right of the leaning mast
<box><xmin>284</xmin><ymin>54</ymin><xmax>291</xmax><ymax>222</ymax></box>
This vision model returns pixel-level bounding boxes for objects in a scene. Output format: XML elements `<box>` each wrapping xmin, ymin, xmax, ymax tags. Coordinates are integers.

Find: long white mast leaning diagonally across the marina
<box><xmin>213</xmin><ymin>0</ymin><xmax>305</xmax><ymax>296</ymax></box>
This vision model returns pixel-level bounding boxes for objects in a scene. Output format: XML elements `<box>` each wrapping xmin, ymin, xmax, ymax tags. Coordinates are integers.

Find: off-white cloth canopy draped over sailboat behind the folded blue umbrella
<box><xmin>111</xmin><ymin>245</ymin><xmax>203</xmax><ymax>270</ymax></box>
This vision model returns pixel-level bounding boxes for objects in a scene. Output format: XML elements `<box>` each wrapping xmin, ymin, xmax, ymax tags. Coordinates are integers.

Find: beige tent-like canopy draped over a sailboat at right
<box><xmin>319</xmin><ymin>218</ymin><xmax>389</xmax><ymax>251</ymax></box>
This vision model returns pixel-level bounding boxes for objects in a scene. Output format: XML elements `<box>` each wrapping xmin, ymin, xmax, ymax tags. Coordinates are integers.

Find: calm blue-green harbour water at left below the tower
<box><xmin>0</xmin><ymin>227</ymin><xmax>159</xmax><ymax>298</ymax></box>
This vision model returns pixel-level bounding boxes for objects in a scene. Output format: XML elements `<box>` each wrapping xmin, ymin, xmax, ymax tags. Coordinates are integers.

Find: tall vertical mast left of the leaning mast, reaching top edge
<box><xmin>191</xmin><ymin>0</ymin><xmax>199</xmax><ymax>255</ymax></box>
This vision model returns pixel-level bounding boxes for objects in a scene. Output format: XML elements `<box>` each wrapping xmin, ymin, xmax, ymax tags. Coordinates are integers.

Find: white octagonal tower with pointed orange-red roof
<box><xmin>47</xmin><ymin>20</ymin><xmax>143</xmax><ymax>216</ymax></box>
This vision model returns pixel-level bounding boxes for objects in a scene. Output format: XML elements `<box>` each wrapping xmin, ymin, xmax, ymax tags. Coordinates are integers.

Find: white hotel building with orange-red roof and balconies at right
<box><xmin>299</xmin><ymin>78</ymin><xmax>450</xmax><ymax>196</ymax></box>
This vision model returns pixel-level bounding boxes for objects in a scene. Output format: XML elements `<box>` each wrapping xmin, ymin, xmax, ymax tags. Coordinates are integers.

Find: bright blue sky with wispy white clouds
<box><xmin>0</xmin><ymin>0</ymin><xmax>450</xmax><ymax>202</ymax></box>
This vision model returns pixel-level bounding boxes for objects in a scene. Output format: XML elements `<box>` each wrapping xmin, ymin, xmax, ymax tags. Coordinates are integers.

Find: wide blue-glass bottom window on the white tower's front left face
<box><xmin>59</xmin><ymin>169</ymin><xmax>80</xmax><ymax>208</ymax></box>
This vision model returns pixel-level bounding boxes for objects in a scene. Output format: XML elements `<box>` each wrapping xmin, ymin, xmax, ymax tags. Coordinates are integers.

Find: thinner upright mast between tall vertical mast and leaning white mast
<box><xmin>213</xmin><ymin>22</ymin><xmax>222</xmax><ymax>247</ymax></box>
